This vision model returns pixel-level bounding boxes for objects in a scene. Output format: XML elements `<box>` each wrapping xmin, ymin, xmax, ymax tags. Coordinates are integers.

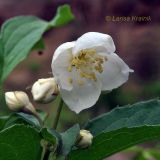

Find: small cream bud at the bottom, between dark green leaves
<box><xmin>76</xmin><ymin>130</ymin><xmax>93</xmax><ymax>148</ymax></box>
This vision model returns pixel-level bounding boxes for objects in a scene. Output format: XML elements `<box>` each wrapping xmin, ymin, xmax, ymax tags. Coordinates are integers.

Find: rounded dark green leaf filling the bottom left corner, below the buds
<box><xmin>0</xmin><ymin>125</ymin><xmax>42</xmax><ymax>160</ymax></box>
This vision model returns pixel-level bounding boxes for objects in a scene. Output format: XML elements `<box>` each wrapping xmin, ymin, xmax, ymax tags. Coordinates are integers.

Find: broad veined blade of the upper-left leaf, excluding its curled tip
<box><xmin>0</xmin><ymin>16</ymin><xmax>48</xmax><ymax>82</ymax></box>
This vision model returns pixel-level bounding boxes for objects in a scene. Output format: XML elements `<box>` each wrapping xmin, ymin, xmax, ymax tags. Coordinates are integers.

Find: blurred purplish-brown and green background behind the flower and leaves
<box><xmin>0</xmin><ymin>0</ymin><xmax>160</xmax><ymax>160</ymax></box>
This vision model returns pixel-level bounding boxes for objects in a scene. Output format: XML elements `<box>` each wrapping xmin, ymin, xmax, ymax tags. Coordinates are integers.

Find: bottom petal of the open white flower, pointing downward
<box><xmin>60</xmin><ymin>80</ymin><xmax>102</xmax><ymax>113</ymax></box>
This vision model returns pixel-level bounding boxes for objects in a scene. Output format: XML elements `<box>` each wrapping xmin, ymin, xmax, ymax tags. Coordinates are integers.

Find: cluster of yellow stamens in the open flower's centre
<box><xmin>68</xmin><ymin>49</ymin><xmax>107</xmax><ymax>85</ymax></box>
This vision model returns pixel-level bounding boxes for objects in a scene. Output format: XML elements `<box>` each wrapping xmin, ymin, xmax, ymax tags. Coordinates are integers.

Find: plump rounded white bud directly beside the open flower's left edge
<box><xmin>31</xmin><ymin>78</ymin><xmax>59</xmax><ymax>103</ymax></box>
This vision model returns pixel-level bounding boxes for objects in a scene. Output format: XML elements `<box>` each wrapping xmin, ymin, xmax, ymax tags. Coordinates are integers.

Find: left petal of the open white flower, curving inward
<box><xmin>51</xmin><ymin>42</ymin><xmax>75</xmax><ymax>90</ymax></box>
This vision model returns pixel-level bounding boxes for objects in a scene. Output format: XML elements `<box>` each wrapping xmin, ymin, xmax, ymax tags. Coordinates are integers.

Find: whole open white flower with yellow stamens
<box><xmin>52</xmin><ymin>32</ymin><xmax>133</xmax><ymax>113</ymax></box>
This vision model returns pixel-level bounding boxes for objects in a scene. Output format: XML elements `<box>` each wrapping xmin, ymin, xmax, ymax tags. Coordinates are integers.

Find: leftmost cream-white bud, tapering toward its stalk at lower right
<box><xmin>5</xmin><ymin>91</ymin><xmax>36</xmax><ymax>113</ymax></box>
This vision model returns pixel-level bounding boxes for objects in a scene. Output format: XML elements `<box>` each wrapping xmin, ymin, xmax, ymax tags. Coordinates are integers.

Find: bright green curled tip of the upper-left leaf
<box><xmin>50</xmin><ymin>5</ymin><xmax>74</xmax><ymax>27</ymax></box>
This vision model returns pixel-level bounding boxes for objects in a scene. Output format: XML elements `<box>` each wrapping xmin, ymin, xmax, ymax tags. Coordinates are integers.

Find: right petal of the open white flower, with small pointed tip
<box><xmin>100</xmin><ymin>53</ymin><xmax>133</xmax><ymax>91</ymax></box>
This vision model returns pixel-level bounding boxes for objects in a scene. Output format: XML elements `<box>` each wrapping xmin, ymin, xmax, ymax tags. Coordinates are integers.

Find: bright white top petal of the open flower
<box><xmin>73</xmin><ymin>32</ymin><xmax>115</xmax><ymax>56</ymax></box>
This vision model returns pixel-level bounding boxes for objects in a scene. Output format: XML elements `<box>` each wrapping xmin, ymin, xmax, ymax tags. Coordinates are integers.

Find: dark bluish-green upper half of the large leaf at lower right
<box><xmin>85</xmin><ymin>99</ymin><xmax>160</xmax><ymax>136</ymax></box>
